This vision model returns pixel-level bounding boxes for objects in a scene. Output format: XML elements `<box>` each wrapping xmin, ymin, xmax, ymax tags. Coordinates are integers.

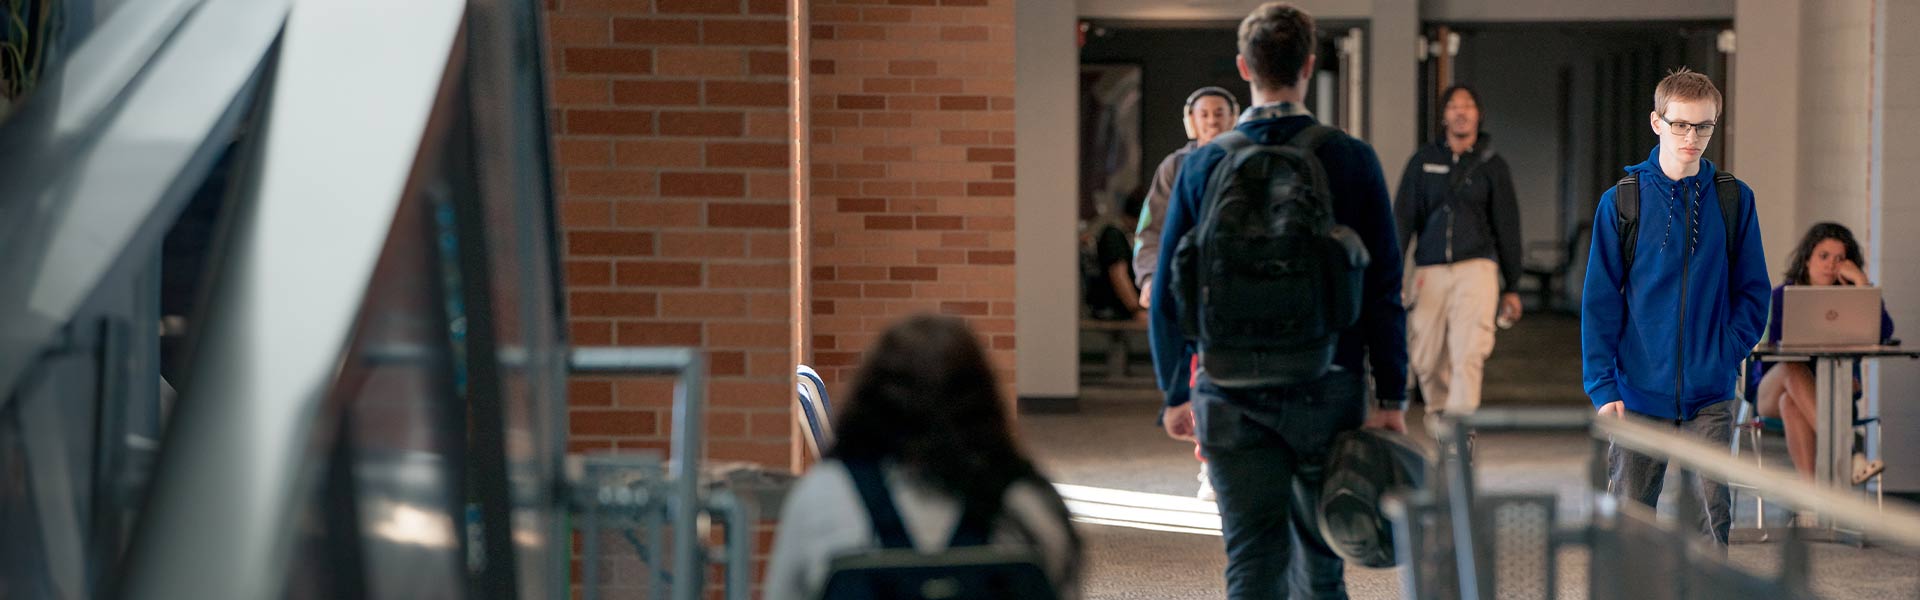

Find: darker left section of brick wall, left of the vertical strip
<box><xmin>547</xmin><ymin>0</ymin><xmax>793</xmax><ymax>461</ymax></box>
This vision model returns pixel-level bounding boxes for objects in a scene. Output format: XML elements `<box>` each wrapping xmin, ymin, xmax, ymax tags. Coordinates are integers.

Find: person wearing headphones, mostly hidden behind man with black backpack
<box><xmin>1133</xmin><ymin>87</ymin><xmax>1240</xmax><ymax>502</ymax></box>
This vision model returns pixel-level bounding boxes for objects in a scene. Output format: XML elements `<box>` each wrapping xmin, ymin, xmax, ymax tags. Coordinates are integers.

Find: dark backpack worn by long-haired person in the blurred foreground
<box><xmin>820</xmin><ymin>462</ymin><xmax>1060</xmax><ymax>600</ymax></box>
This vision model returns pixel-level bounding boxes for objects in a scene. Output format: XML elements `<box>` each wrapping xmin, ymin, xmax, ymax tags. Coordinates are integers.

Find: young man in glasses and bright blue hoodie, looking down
<box><xmin>1580</xmin><ymin>69</ymin><xmax>1770</xmax><ymax>548</ymax></box>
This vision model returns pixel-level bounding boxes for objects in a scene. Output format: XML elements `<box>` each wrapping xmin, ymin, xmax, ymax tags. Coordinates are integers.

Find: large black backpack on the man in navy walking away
<box><xmin>1169</xmin><ymin>125</ymin><xmax>1369</xmax><ymax>388</ymax></box>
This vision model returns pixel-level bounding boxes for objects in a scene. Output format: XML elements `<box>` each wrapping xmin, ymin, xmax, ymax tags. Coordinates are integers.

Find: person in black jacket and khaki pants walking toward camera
<box><xmin>1394</xmin><ymin>85</ymin><xmax>1521</xmax><ymax>426</ymax></box>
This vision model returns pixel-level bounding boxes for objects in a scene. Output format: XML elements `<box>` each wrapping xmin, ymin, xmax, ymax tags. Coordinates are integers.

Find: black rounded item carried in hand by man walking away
<box><xmin>1317</xmin><ymin>429</ymin><xmax>1430</xmax><ymax>569</ymax></box>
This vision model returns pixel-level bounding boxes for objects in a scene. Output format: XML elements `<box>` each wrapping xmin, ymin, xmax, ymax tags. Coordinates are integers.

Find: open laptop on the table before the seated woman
<box><xmin>1780</xmin><ymin>285</ymin><xmax>1880</xmax><ymax>348</ymax></box>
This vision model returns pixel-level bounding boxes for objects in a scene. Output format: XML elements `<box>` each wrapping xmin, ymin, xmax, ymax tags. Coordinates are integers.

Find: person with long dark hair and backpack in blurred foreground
<box><xmin>766</xmin><ymin>315</ymin><xmax>1081</xmax><ymax>600</ymax></box>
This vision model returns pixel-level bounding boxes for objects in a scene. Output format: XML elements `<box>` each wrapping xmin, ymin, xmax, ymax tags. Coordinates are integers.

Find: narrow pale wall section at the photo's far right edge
<box><xmin>1866</xmin><ymin>2</ymin><xmax>1920</xmax><ymax>492</ymax></box>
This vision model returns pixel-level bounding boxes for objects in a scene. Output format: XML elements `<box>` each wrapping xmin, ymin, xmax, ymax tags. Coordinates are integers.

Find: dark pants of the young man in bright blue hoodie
<box><xmin>1607</xmin><ymin>400</ymin><xmax>1736</xmax><ymax>548</ymax></box>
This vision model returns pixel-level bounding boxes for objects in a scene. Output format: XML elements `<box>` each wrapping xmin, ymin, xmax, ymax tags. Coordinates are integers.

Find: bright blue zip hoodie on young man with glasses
<box><xmin>1580</xmin><ymin>146</ymin><xmax>1772</xmax><ymax>419</ymax></box>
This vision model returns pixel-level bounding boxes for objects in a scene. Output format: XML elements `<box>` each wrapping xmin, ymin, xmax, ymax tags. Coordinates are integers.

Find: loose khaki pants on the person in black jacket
<box><xmin>1407</xmin><ymin>258</ymin><xmax>1500</xmax><ymax>415</ymax></box>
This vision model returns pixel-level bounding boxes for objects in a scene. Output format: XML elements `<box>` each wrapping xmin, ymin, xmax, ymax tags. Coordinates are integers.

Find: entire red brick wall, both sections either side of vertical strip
<box><xmin>547</xmin><ymin>0</ymin><xmax>1014</xmax><ymax>596</ymax></box>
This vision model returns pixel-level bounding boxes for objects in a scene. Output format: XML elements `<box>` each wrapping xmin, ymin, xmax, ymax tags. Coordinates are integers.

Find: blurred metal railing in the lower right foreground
<box><xmin>1386</xmin><ymin>410</ymin><xmax>1920</xmax><ymax>598</ymax></box>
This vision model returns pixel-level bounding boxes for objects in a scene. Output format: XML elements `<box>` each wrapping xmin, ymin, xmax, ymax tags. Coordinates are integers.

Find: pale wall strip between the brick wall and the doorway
<box><xmin>1014</xmin><ymin>0</ymin><xmax>1079</xmax><ymax>398</ymax></box>
